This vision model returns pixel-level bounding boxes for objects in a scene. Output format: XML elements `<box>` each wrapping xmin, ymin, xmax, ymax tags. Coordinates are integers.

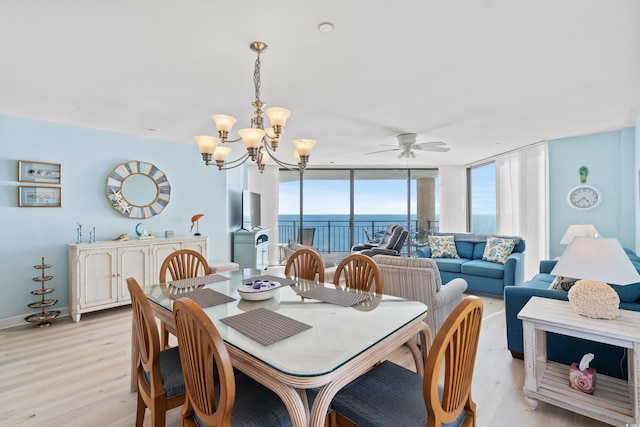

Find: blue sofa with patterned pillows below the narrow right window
<box><xmin>417</xmin><ymin>232</ymin><xmax>526</xmax><ymax>296</ymax></box>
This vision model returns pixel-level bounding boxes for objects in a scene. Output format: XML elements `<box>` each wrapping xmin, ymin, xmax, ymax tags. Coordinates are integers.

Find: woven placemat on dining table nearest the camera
<box><xmin>220</xmin><ymin>308</ymin><xmax>311</xmax><ymax>345</ymax></box>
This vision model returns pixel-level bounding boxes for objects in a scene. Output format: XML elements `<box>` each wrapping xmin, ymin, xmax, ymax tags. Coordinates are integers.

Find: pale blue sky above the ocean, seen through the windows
<box><xmin>279</xmin><ymin>164</ymin><xmax>496</xmax><ymax>215</ymax></box>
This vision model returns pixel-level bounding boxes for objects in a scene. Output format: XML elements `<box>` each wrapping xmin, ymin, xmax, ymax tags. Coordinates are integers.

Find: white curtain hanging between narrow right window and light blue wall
<box><xmin>495</xmin><ymin>142</ymin><xmax>548</xmax><ymax>280</ymax></box>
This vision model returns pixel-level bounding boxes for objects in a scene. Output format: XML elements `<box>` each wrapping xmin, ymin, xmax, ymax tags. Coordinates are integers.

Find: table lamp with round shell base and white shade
<box><xmin>551</xmin><ymin>237</ymin><xmax>640</xmax><ymax>319</ymax></box>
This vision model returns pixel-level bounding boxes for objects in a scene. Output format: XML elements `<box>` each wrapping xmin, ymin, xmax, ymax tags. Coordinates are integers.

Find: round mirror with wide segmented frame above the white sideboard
<box><xmin>107</xmin><ymin>161</ymin><xmax>171</xmax><ymax>218</ymax></box>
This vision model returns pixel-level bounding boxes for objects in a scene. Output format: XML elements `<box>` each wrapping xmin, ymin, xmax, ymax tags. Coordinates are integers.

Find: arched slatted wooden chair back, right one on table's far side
<box><xmin>333</xmin><ymin>254</ymin><xmax>382</xmax><ymax>294</ymax></box>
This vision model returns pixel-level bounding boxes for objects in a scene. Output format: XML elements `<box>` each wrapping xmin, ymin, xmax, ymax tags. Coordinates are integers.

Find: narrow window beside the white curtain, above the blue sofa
<box><xmin>468</xmin><ymin>163</ymin><xmax>497</xmax><ymax>234</ymax></box>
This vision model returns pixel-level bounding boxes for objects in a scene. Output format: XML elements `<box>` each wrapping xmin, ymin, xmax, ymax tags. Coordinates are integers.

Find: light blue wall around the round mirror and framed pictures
<box><xmin>0</xmin><ymin>115</ymin><xmax>247</xmax><ymax>323</ymax></box>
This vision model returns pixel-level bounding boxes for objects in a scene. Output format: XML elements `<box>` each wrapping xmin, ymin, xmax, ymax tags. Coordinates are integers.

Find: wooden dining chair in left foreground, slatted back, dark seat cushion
<box><xmin>173</xmin><ymin>298</ymin><xmax>291</xmax><ymax>427</ymax></box>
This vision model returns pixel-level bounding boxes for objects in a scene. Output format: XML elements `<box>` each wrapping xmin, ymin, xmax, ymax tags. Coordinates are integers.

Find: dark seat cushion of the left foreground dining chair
<box><xmin>194</xmin><ymin>373</ymin><xmax>291</xmax><ymax>427</ymax></box>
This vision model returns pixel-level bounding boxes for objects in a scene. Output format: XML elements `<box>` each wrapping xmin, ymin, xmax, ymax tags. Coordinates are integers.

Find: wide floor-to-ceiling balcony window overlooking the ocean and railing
<box><xmin>279</xmin><ymin>169</ymin><xmax>438</xmax><ymax>253</ymax></box>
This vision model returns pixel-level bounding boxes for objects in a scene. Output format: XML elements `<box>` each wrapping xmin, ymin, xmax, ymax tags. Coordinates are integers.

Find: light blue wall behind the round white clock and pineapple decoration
<box><xmin>548</xmin><ymin>128</ymin><xmax>637</xmax><ymax>258</ymax></box>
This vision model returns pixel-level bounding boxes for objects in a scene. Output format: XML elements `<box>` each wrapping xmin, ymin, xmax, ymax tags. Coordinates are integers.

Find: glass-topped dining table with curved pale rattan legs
<box><xmin>131</xmin><ymin>269</ymin><xmax>428</xmax><ymax>427</ymax></box>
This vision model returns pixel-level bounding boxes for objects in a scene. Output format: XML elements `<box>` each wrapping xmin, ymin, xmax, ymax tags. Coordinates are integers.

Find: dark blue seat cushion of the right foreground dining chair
<box><xmin>331</xmin><ymin>361</ymin><xmax>466</xmax><ymax>427</ymax></box>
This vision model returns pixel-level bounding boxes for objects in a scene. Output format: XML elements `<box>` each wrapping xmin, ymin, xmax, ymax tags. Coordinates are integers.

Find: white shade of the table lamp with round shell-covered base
<box><xmin>551</xmin><ymin>237</ymin><xmax>640</xmax><ymax>285</ymax></box>
